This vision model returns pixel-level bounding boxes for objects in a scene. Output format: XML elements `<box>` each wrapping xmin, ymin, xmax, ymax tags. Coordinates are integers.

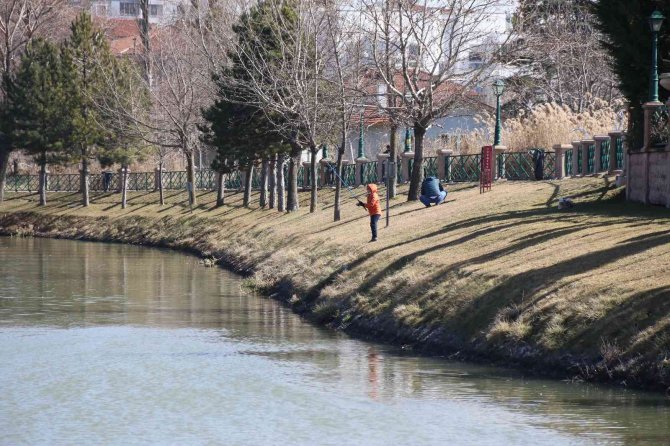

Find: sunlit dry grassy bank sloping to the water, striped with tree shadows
<box><xmin>0</xmin><ymin>178</ymin><xmax>670</xmax><ymax>390</ymax></box>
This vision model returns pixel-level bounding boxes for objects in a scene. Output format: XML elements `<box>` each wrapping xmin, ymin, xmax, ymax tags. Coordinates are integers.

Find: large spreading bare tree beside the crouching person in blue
<box><xmin>363</xmin><ymin>0</ymin><xmax>509</xmax><ymax>200</ymax></box>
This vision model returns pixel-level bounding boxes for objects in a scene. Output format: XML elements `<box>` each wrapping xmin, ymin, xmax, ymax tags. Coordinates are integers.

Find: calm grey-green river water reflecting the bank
<box><xmin>0</xmin><ymin>238</ymin><xmax>670</xmax><ymax>446</ymax></box>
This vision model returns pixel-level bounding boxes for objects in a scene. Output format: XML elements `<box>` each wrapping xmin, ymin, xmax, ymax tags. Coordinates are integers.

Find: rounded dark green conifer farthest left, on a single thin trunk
<box><xmin>8</xmin><ymin>39</ymin><xmax>74</xmax><ymax>205</ymax></box>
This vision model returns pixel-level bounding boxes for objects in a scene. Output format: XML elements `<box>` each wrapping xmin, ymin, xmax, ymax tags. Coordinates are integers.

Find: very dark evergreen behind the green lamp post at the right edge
<box><xmin>593</xmin><ymin>0</ymin><xmax>670</xmax><ymax>149</ymax></box>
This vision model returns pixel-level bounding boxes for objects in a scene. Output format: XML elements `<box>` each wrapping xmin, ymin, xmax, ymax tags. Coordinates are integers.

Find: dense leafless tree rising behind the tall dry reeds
<box><xmin>504</xmin><ymin>0</ymin><xmax>621</xmax><ymax>113</ymax></box>
